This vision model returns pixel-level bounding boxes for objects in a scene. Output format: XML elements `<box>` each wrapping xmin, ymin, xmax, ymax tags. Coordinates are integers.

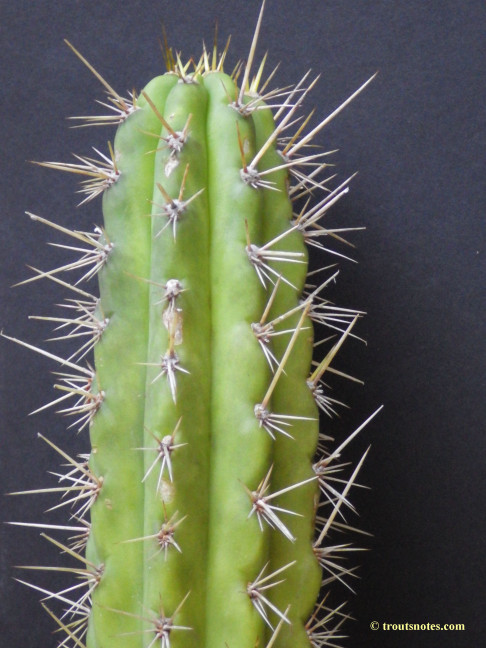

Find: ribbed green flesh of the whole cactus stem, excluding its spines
<box><xmin>87</xmin><ymin>72</ymin><xmax>320</xmax><ymax>648</ymax></box>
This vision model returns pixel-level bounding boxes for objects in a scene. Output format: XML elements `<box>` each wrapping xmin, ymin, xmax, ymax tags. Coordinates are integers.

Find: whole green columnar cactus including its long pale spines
<box><xmin>4</xmin><ymin>3</ymin><xmax>382</xmax><ymax>648</ymax></box>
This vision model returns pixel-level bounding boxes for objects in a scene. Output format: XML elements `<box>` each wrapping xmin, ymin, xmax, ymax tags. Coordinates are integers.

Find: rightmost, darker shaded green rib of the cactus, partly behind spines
<box><xmin>254</xmin><ymin>104</ymin><xmax>322</xmax><ymax>648</ymax></box>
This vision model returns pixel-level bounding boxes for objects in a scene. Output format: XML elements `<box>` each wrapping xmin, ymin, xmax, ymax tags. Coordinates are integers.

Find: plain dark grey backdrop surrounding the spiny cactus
<box><xmin>0</xmin><ymin>0</ymin><xmax>486</xmax><ymax>648</ymax></box>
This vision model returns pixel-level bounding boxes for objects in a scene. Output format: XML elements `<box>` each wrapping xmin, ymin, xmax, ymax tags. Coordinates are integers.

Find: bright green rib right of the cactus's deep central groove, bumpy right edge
<box><xmin>205</xmin><ymin>74</ymin><xmax>271</xmax><ymax>648</ymax></box>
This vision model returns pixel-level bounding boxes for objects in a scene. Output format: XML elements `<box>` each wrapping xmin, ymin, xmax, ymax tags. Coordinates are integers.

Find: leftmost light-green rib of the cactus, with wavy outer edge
<box><xmin>87</xmin><ymin>76</ymin><xmax>176</xmax><ymax>648</ymax></box>
